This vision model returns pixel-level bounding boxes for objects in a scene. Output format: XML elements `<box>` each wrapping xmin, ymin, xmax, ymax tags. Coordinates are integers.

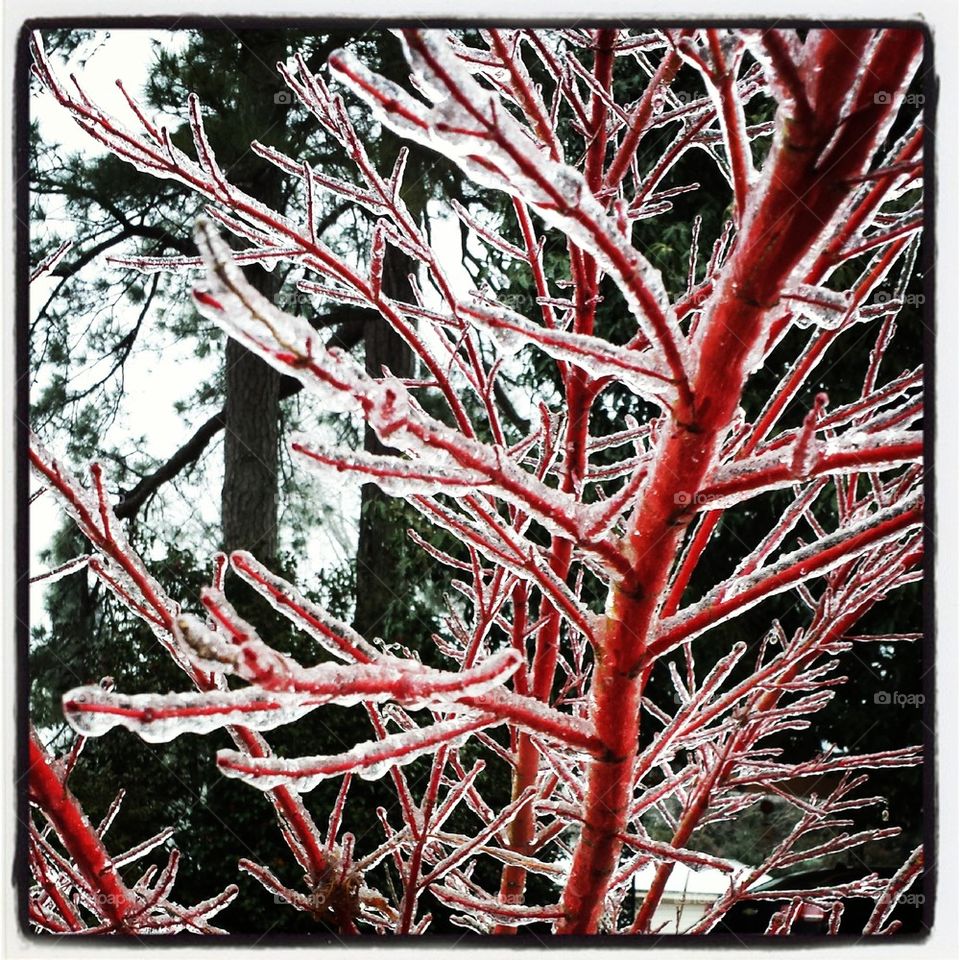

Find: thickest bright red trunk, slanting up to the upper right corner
<box><xmin>558</xmin><ymin>31</ymin><xmax>920</xmax><ymax>933</ymax></box>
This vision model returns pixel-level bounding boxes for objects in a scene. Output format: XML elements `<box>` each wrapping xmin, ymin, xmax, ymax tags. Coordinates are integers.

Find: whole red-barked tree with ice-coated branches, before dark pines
<box><xmin>29</xmin><ymin>25</ymin><xmax>924</xmax><ymax>934</ymax></box>
